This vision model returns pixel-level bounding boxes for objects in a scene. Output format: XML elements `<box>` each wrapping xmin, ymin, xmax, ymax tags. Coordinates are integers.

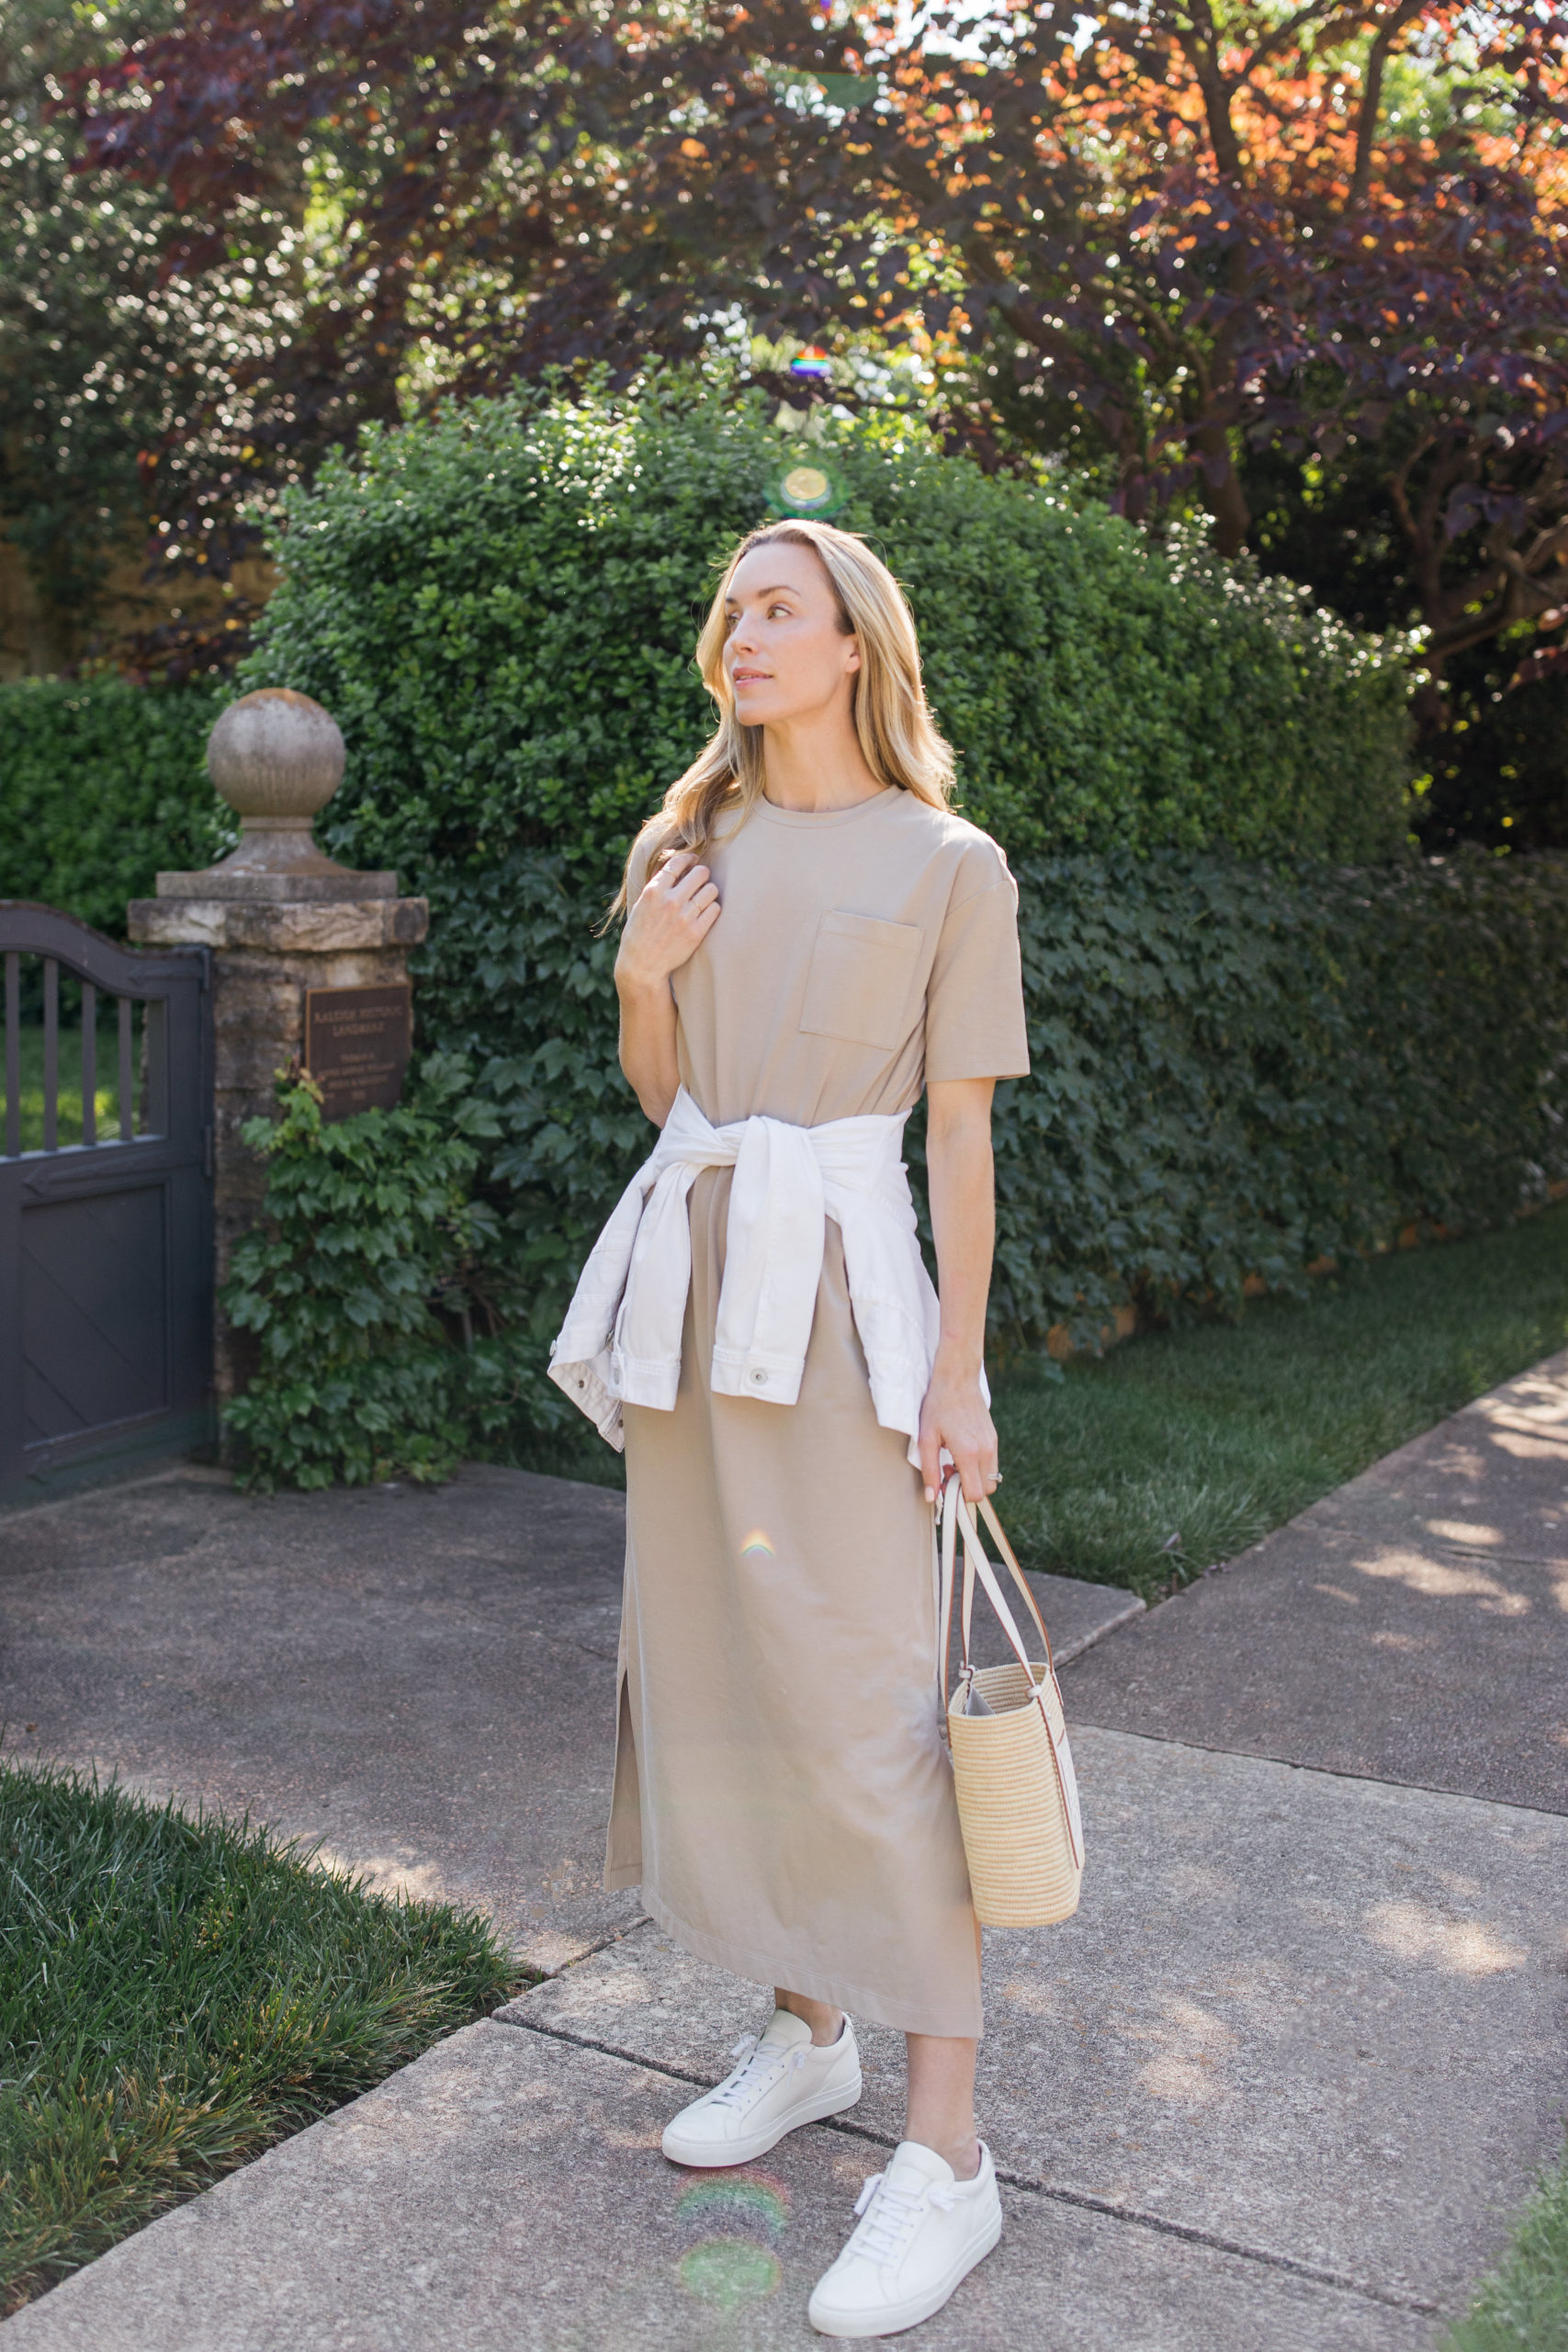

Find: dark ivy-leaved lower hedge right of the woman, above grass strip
<box><xmin>992</xmin><ymin>854</ymin><xmax>1568</xmax><ymax>1343</ymax></box>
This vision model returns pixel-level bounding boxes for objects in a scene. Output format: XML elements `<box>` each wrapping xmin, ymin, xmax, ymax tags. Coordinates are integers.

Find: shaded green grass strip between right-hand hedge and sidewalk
<box><xmin>995</xmin><ymin>1202</ymin><xmax>1568</xmax><ymax>1597</ymax></box>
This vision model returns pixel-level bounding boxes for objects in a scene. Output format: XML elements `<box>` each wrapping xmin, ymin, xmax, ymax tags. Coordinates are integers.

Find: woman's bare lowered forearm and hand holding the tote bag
<box><xmin>919</xmin><ymin>1077</ymin><xmax>997</xmax><ymax>1503</ymax></box>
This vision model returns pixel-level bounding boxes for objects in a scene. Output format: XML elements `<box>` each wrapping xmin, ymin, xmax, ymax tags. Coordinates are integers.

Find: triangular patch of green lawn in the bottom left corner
<box><xmin>0</xmin><ymin>1761</ymin><xmax>517</xmax><ymax>2314</ymax></box>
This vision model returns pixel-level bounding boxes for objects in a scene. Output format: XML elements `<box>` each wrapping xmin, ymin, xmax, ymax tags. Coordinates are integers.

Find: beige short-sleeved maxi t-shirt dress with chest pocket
<box><xmin>606</xmin><ymin>788</ymin><xmax>1030</xmax><ymax>2034</ymax></box>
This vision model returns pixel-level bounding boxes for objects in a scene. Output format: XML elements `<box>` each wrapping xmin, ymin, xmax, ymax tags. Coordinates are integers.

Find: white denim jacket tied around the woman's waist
<box><xmin>550</xmin><ymin>1087</ymin><xmax>968</xmax><ymax>1465</ymax></box>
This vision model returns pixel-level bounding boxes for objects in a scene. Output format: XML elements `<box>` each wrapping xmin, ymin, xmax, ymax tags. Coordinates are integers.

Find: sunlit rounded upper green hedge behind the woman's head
<box><xmin>240</xmin><ymin>381</ymin><xmax>1408</xmax><ymax>884</ymax></box>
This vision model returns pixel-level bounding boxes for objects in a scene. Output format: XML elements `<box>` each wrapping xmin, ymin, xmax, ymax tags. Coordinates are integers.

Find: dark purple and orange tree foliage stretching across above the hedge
<box><xmin>80</xmin><ymin>0</ymin><xmax>1568</xmax><ymax>724</ymax></box>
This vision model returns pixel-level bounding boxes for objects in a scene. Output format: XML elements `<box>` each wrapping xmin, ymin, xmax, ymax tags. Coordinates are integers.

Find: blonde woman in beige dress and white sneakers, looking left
<box><xmin>552</xmin><ymin>522</ymin><xmax>1027</xmax><ymax>2338</ymax></box>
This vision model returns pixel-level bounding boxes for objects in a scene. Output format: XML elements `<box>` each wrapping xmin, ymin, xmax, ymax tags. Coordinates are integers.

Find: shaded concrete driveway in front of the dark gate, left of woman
<box><xmin>0</xmin><ymin>1467</ymin><xmax>1140</xmax><ymax>1969</ymax></box>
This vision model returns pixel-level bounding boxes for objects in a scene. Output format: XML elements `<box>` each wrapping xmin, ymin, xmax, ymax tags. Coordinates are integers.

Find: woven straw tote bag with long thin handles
<box><xmin>938</xmin><ymin>1473</ymin><xmax>1084</xmax><ymax>1927</ymax></box>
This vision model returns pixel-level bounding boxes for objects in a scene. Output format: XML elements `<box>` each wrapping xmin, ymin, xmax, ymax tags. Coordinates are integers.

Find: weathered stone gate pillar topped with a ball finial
<box><xmin>130</xmin><ymin>687</ymin><xmax>430</xmax><ymax>1411</ymax></box>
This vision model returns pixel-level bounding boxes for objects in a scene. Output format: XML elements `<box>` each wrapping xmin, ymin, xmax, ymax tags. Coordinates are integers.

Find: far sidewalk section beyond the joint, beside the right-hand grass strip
<box><xmin>1072</xmin><ymin>1352</ymin><xmax>1568</xmax><ymax>1814</ymax></box>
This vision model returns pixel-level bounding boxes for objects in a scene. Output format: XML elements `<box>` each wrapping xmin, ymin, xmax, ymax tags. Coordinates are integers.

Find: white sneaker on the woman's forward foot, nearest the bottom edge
<box><xmin>807</xmin><ymin>2141</ymin><xmax>1001</xmax><ymax>2335</ymax></box>
